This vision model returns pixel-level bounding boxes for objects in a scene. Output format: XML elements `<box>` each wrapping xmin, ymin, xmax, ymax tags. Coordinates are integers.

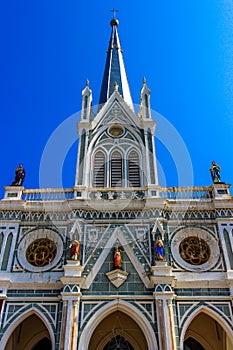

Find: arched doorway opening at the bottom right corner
<box><xmin>183</xmin><ymin>312</ymin><xmax>233</xmax><ymax>350</ymax></box>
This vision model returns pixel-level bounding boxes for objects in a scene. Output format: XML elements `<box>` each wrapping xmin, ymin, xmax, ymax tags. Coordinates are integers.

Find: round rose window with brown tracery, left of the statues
<box><xmin>26</xmin><ymin>238</ymin><xmax>57</xmax><ymax>267</ymax></box>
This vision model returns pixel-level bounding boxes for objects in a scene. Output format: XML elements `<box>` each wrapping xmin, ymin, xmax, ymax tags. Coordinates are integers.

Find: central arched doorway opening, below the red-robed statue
<box><xmin>88</xmin><ymin>311</ymin><xmax>148</xmax><ymax>350</ymax></box>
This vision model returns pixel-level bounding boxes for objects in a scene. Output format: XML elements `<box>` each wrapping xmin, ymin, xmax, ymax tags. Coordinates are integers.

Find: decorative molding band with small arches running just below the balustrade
<box><xmin>0</xmin><ymin>208</ymin><xmax>233</xmax><ymax>223</ymax></box>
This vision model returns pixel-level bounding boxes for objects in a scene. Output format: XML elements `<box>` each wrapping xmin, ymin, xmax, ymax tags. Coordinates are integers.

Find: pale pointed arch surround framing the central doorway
<box><xmin>78</xmin><ymin>300</ymin><xmax>158</xmax><ymax>350</ymax></box>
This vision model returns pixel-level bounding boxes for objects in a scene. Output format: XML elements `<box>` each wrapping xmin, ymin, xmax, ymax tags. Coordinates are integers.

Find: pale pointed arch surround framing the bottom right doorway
<box><xmin>180</xmin><ymin>306</ymin><xmax>233</xmax><ymax>350</ymax></box>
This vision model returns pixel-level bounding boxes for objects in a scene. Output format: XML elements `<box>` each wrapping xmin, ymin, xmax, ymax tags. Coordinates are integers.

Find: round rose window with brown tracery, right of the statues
<box><xmin>179</xmin><ymin>236</ymin><xmax>210</xmax><ymax>265</ymax></box>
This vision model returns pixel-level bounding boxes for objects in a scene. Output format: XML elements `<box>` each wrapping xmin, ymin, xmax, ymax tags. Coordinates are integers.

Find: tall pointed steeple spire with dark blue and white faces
<box><xmin>99</xmin><ymin>17</ymin><xmax>133</xmax><ymax>107</ymax></box>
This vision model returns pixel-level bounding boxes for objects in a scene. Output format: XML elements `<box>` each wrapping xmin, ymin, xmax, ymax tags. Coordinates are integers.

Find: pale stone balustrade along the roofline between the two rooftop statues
<box><xmin>1</xmin><ymin>184</ymin><xmax>231</xmax><ymax>201</ymax></box>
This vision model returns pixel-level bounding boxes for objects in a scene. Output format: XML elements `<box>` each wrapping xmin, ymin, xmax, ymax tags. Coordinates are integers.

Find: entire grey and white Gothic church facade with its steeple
<box><xmin>0</xmin><ymin>18</ymin><xmax>233</xmax><ymax>350</ymax></box>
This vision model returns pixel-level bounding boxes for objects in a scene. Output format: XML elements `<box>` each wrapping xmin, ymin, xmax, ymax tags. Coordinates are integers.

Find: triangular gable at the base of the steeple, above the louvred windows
<box><xmin>91</xmin><ymin>91</ymin><xmax>140</xmax><ymax>129</ymax></box>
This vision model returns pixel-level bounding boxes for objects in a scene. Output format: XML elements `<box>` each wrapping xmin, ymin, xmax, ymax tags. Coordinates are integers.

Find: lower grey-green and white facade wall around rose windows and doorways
<box><xmin>0</xmin><ymin>193</ymin><xmax>233</xmax><ymax>350</ymax></box>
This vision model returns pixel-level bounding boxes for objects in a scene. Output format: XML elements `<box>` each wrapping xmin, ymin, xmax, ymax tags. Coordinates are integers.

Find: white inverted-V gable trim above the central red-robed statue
<box><xmin>85</xmin><ymin>227</ymin><xmax>150</xmax><ymax>288</ymax></box>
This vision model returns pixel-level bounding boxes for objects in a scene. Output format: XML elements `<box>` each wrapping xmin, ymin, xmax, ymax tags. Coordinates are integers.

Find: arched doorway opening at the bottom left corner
<box><xmin>5</xmin><ymin>314</ymin><xmax>52</xmax><ymax>350</ymax></box>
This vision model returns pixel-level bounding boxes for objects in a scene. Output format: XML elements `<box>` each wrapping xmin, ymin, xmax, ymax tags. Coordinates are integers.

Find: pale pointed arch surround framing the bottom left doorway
<box><xmin>0</xmin><ymin>307</ymin><xmax>55</xmax><ymax>350</ymax></box>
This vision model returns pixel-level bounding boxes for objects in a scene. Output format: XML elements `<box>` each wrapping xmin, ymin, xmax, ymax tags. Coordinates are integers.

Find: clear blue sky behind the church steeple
<box><xmin>0</xmin><ymin>0</ymin><xmax>233</xmax><ymax>197</ymax></box>
